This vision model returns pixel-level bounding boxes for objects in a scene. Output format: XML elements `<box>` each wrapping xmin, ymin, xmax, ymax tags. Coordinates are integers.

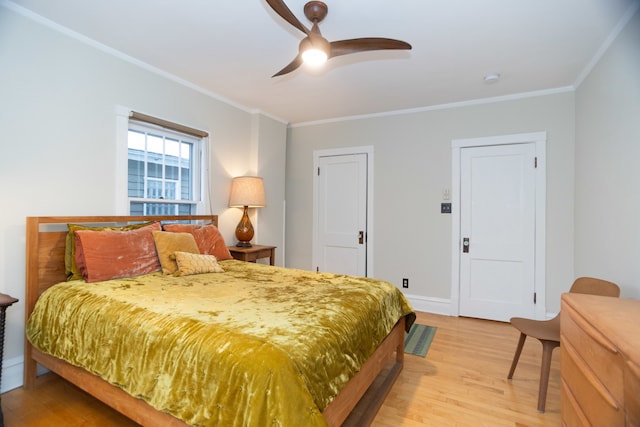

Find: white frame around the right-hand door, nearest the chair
<box><xmin>450</xmin><ymin>132</ymin><xmax>547</xmax><ymax>320</ymax></box>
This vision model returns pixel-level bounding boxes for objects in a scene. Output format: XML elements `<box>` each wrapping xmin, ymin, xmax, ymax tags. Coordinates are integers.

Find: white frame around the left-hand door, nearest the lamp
<box><xmin>311</xmin><ymin>145</ymin><xmax>375</xmax><ymax>277</ymax></box>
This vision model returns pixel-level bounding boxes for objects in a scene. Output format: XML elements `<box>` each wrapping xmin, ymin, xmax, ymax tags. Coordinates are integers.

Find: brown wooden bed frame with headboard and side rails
<box><xmin>24</xmin><ymin>215</ymin><xmax>405</xmax><ymax>427</ymax></box>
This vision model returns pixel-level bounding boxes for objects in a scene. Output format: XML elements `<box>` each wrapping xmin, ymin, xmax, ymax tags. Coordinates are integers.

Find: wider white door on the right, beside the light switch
<box><xmin>460</xmin><ymin>143</ymin><xmax>536</xmax><ymax>321</ymax></box>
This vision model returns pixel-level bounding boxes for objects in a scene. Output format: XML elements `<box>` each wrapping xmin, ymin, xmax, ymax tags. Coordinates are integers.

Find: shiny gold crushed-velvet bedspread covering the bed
<box><xmin>27</xmin><ymin>260</ymin><xmax>415</xmax><ymax>427</ymax></box>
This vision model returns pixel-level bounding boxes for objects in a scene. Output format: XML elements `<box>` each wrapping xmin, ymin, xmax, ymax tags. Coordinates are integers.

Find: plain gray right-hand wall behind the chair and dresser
<box><xmin>575</xmin><ymin>8</ymin><xmax>640</xmax><ymax>298</ymax></box>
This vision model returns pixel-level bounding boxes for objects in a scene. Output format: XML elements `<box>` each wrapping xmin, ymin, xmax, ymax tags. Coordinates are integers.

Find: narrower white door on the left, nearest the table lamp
<box><xmin>315</xmin><ymin>154</ymin><xmax>367</xmax><ymax>276</ymax></box>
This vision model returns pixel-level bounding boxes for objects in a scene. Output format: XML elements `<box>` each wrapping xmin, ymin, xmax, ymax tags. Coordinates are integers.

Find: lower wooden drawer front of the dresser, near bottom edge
<box><xmin>560</xmin><ymin>339</ymin><xmax>624</xmax><ymax>427</ymax></box>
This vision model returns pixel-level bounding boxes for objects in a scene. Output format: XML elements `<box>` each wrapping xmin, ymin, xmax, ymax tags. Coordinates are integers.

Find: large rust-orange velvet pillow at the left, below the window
<box><xmin>75</xmin><ymin>222</ymin><xmax>162</xmax><ymax>282</ymax></box>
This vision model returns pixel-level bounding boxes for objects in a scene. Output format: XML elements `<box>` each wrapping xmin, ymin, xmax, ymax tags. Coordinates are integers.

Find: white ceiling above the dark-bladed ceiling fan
<box><xmin>6</xmin><ymin>0</ymin><xmax>639</xmax><ymax>124</ymax></box>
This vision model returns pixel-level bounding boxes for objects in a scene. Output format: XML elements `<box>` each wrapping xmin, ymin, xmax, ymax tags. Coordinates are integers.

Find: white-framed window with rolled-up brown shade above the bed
<box><xmin>127</xmin><ymin>113</ymin><xmax>206</xmax><ymax>215</ymax></box>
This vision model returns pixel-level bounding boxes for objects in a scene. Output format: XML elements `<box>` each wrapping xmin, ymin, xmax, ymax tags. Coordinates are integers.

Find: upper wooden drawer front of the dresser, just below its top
<box><xmin>561</xmin><ymin>300</ymin><xmax>624</xmax><ymax>402</ymax></box>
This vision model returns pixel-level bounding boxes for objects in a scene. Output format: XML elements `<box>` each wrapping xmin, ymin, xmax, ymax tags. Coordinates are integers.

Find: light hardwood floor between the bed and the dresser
<box><xmin>373</xmin><ymin>313</ymin><xmax>560</xmax><ymax>427</ymax></box>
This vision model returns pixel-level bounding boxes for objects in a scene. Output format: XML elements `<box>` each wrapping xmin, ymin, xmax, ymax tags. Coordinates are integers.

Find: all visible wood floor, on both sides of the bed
<box><xmin>2</xmin><ymin>313</ymin><xmax>560</xmax><ymax>427</ymax></box>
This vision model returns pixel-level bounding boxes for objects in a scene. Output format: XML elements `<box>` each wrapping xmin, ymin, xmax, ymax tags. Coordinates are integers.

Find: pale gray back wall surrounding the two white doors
<box><xmin>286</xmin><ymin>92</ymin><xmax>574</xmax><ymax>312</ymax></box>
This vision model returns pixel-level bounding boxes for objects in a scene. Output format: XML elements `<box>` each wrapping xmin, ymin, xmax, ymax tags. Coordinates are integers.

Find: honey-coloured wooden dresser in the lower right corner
<box><xmin>560</xmin><ymin>294</ymin><xmax>640</xmax><ymax>427</ymax></box>
